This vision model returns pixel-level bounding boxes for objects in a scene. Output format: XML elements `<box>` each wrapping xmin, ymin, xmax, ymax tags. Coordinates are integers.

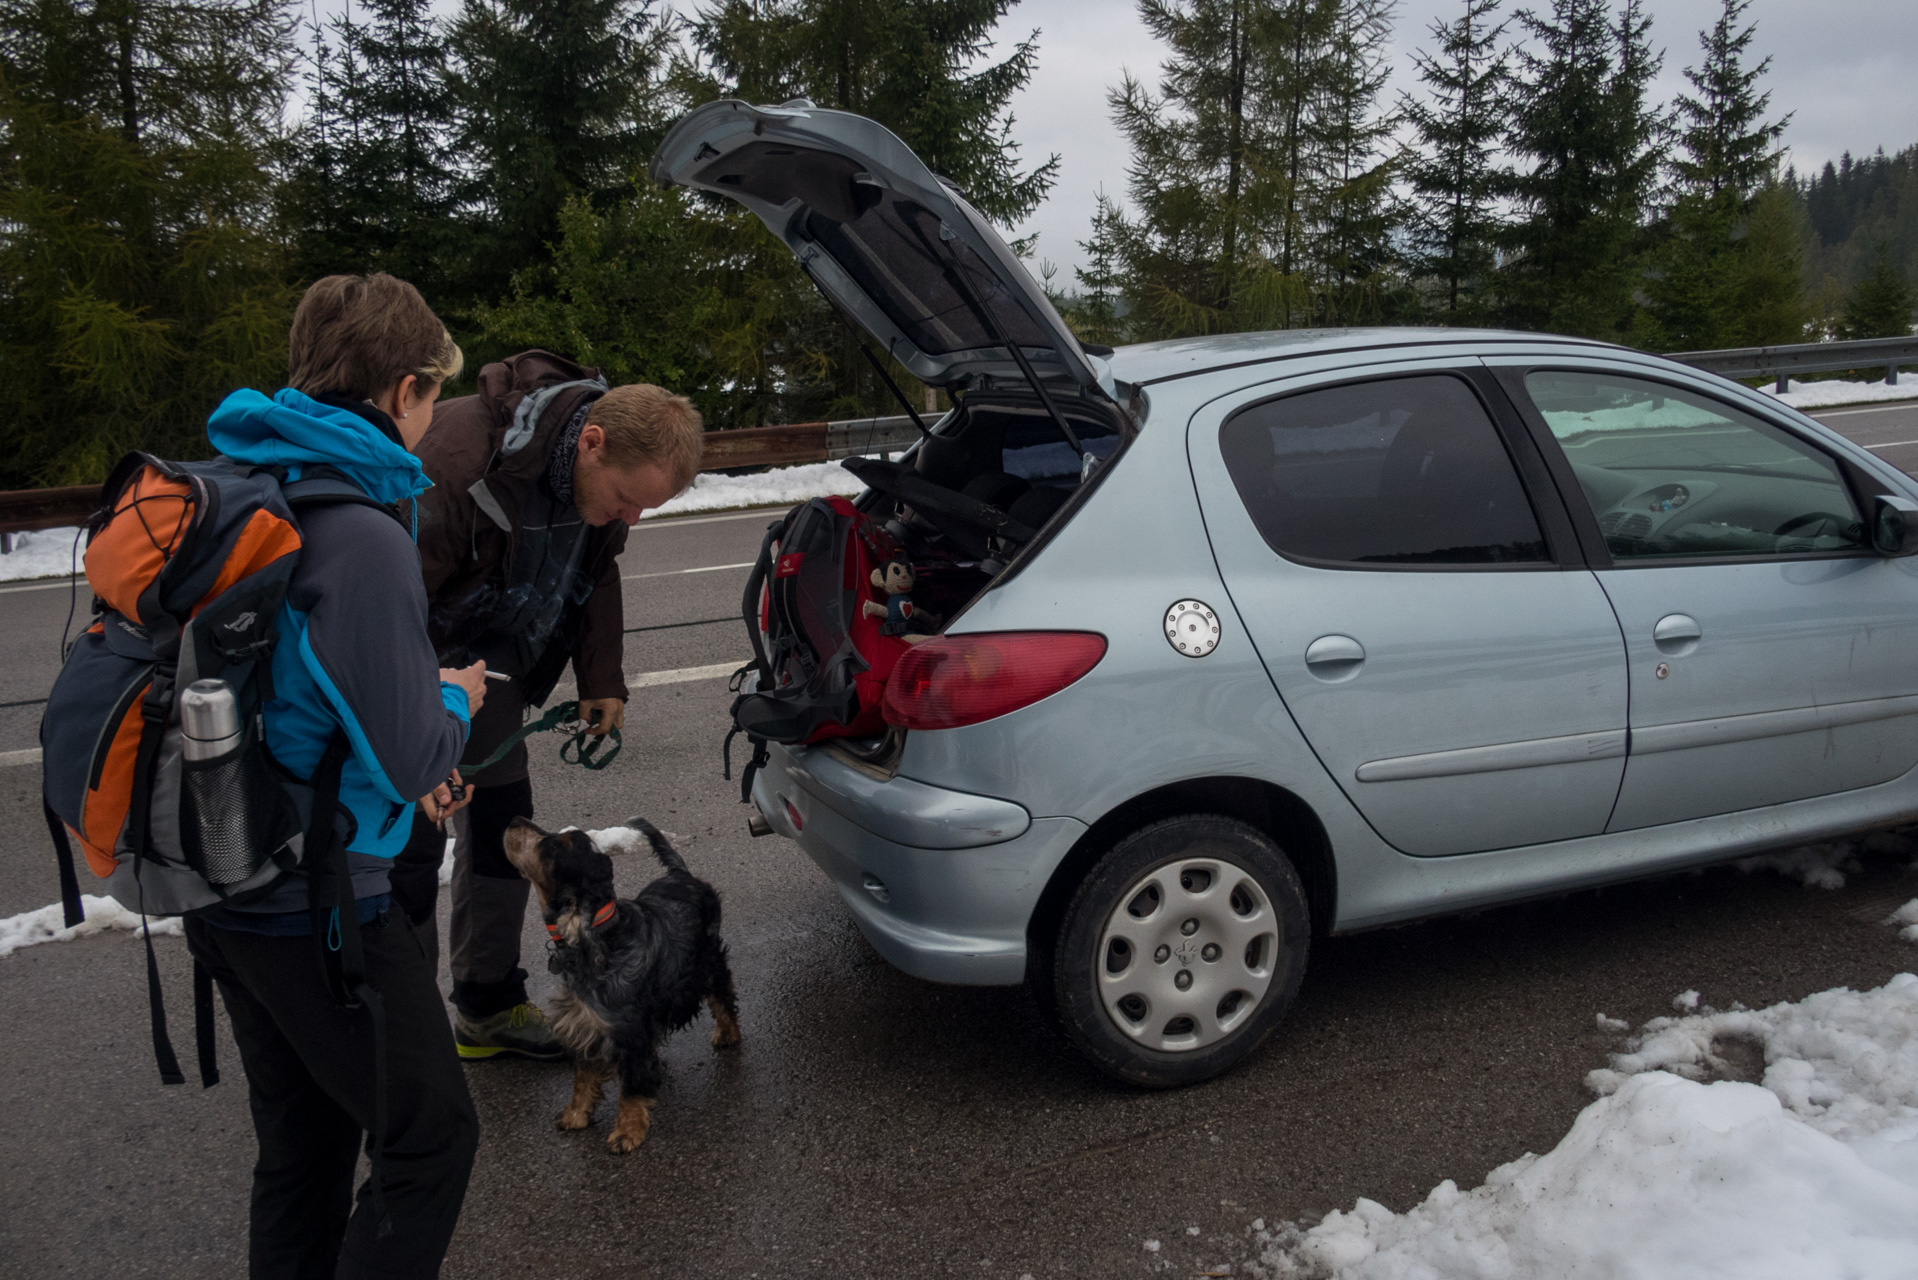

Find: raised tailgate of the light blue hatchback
<box><xmin>652</xmin><ymin>100</ymin><xmax>1118</xmax><ymax>401</ymax></box>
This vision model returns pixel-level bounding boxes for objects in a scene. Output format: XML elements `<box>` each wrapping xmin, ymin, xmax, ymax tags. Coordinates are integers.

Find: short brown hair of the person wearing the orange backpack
<box><xmin>286</xmin><ymin>273</ymin><xmax>466</xmax><ymax>399</ymax></box>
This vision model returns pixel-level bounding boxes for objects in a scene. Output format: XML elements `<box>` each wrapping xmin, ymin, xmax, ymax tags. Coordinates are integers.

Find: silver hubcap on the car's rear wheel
<box><xmin>1095</xmin><ymin>858</ymin><xmax>1279</xmax><ymax>1054</ymax></box>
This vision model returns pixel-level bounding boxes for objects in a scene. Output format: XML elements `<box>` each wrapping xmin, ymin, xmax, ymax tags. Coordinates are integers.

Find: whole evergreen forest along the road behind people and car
<box><xmin>0</xmin><ymin>0</ymin><xmax>1918</xmax><ymax>487</ymax></box>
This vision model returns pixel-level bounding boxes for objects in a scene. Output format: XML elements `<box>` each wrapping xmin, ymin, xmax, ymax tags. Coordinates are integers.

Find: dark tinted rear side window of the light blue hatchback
<box><xmin>1220</xmin><ymin>374</ymin><xmax>1550</xmax><ymax>566</ymax></box>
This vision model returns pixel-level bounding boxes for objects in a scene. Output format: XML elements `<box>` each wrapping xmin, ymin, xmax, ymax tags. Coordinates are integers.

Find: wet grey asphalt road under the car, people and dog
<box><xmin>0</xmin><ymin>405</ymin><xmax>1918</xmax><ymax>1280</ymax></box>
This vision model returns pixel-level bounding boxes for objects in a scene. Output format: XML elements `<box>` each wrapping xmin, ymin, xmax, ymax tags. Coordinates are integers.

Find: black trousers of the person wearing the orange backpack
<box><xmin>186</xmin><ymin>912</ymin><xmax>480</xmax><ymax>1280</ymax></box>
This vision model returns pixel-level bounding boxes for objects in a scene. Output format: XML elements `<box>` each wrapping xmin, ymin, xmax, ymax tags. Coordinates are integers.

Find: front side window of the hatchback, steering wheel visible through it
<box><xmin>1525</xmin><ymin>370</ymin><xmax>1866</xmax><ymax>560</ymax></box>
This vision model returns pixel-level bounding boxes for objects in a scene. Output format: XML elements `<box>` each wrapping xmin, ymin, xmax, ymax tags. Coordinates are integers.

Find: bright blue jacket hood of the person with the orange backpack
<box><xmin>207</xmin><ymin>388</ymin><xmax>433</xmax><ymax>503</ymax></box>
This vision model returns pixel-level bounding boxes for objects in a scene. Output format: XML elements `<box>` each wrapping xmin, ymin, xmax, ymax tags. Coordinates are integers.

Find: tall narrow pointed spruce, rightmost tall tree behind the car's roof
<box><xmin>1649</xmin><ymin>0</ymin><xmax>1803</xmax><ymax>351</ymax></box>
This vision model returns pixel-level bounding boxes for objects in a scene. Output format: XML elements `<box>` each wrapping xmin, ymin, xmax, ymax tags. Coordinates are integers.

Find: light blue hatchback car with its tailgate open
<box><xmin>654</xmin><ymin>102</ymin><xmax>1918</xmax><ymax>1086</ymax></box>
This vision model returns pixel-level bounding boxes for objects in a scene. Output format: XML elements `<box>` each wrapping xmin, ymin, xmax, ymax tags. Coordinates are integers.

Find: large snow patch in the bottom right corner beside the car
<box><xmin>1258</xmin><ymin>973</ymin><xmax>1918</xmax><ymax>1280</ymax></box>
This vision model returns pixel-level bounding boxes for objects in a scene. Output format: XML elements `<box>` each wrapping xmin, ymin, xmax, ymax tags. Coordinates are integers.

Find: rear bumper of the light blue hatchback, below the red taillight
<box><xmin>752</xmin><ymin>745</ymin><xmax>1086</xmax><ymax>986</ymax></box>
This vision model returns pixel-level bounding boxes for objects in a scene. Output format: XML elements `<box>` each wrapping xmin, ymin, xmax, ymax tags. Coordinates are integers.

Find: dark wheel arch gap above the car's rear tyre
<box><xmin>1026</xmin><ymin>777</ymin><xmax>1339</xmax><ymax>975</ymax></box>
